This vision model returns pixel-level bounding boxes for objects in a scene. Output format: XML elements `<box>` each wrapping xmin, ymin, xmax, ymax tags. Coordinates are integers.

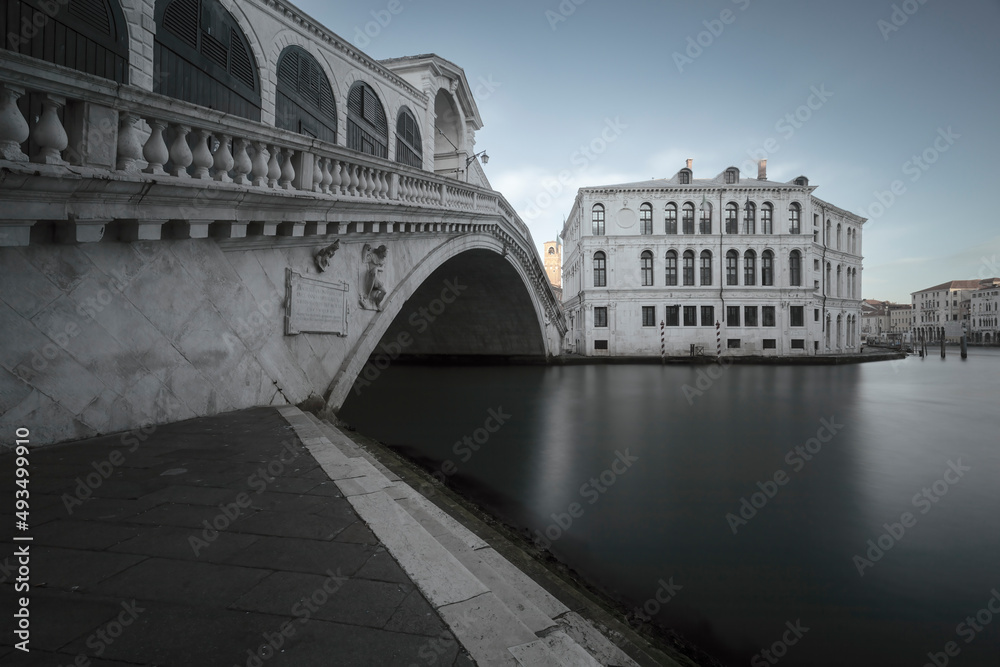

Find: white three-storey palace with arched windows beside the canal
<box><xmin>562</xmin><ymin>160</ymin><xmax>866</xmax><ymax>356</ymax></box>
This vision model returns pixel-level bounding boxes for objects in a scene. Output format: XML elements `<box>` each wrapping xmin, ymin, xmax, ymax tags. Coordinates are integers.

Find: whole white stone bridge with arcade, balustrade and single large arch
<box><xmin>0</xmin><ymin>0</ymin><xmax>566</xmax><ymax>444</ymax></box>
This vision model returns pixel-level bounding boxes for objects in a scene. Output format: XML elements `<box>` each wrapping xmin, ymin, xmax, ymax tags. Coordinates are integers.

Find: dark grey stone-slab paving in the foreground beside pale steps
<box><xmin>0</xmin><ymin>408</ymin><xmax>473</xmax><ymax>667</ymax></box>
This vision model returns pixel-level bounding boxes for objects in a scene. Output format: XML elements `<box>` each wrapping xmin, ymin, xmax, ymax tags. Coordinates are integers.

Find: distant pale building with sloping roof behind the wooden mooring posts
<box><xmin>911</xmin><ymin>278</ymin><xmax>1000</xmax><ymax>342</ymax></box>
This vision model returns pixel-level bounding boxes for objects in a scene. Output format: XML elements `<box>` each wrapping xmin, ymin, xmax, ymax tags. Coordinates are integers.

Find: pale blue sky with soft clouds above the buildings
<box><xmin>296</xmin><ymin>0</ymin><xmax>1000</xmax><ymax>303</ymax></box>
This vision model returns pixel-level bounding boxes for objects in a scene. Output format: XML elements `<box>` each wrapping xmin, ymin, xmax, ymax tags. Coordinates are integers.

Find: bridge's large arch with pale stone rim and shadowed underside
<box><xmin>325</xmin><ymin>233</ymin><xmax>558</xmax><ymax>411</ymax></box>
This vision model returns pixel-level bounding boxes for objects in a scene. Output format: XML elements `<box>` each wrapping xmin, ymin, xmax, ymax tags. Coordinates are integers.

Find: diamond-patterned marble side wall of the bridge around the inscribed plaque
<box><xmin>0</xmin><ymin>236</ymin><xmax>544</xmax><ymax>444</ymax></box>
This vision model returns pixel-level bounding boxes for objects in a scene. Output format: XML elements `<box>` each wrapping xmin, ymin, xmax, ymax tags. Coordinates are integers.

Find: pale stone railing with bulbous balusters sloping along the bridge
<box><xmin>0</xmin><ymin>51</ymin><xmax>561</xmax><ymax>332</ymax></box>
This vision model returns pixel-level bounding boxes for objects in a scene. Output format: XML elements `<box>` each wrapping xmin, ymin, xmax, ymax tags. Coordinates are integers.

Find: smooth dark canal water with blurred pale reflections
<box><xmin>340</xmin><ymin>348</ymin><xmax>1000</xmax><ymax>667</ymax></box>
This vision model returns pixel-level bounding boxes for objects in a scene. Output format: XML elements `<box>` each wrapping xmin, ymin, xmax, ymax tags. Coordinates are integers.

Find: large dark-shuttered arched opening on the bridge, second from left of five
<box><xmin>153</xmin><ymin>0</ymin><xmax>260</xmax><ymax>120</ymax></box>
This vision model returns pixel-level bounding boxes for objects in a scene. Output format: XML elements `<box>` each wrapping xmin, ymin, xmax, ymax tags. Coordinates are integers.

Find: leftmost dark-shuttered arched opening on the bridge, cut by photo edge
<box><xmin>0</xmin><ymin>0</ymin><xmax>129</xmax><ymax>83</ymax></box>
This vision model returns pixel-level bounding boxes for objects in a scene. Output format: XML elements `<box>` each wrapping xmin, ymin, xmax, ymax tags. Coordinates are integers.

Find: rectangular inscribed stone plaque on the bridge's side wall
<box><xmin>285</xmin><ymin>269</ymin><xmax>348</xmax><ymax>336</ymax></box>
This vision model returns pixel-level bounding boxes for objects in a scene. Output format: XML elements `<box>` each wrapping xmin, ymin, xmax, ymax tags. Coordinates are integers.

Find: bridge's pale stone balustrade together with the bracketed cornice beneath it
<box><xmin>0</xmin><ymin>52</ymin><xmax>562</xmax><ymax>332</ymax></box>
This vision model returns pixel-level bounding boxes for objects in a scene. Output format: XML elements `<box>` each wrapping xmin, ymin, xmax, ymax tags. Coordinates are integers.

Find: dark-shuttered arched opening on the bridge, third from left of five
<box><xmin>274</xmin><ymin>46</ymin><xmax>337</xmax><ymax>144</ymax></box>
